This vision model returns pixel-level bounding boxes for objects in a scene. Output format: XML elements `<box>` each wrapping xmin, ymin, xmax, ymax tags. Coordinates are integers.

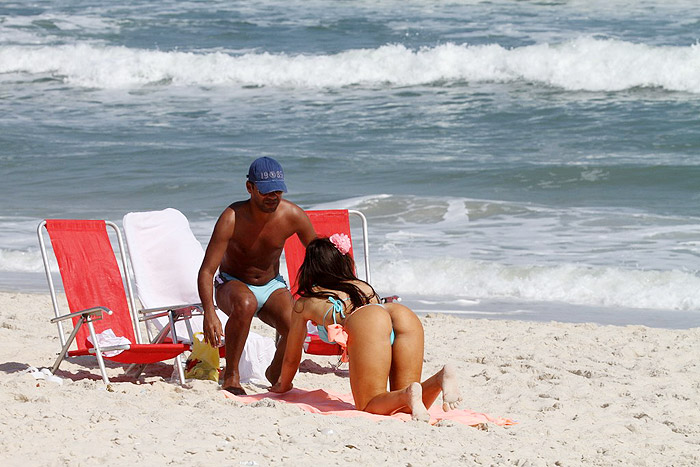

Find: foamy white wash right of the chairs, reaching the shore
<box><xmin>315</xmin><ymin>195</ymin><xmax>700</xmax><ymax>311</ymax></box>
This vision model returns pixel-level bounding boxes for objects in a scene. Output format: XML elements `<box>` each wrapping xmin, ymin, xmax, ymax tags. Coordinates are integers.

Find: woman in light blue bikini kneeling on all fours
<box><xmin>270</xmin><ymin>234</ymin><xmax>462</xmax><ymax>422</ymax></box>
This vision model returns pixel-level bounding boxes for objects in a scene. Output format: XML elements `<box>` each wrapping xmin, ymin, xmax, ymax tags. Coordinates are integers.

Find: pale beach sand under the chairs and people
<box><xmin>0</xmin><ymin>293</ymin><xmax>700</xmax><ymax>466</ymax></box>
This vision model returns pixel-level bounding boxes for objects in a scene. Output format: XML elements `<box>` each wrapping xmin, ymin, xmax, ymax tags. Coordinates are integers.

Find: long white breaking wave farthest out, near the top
<box><xmin>0</xmin><ymin>37</ymin><xmax>700</xmax><ymax>93</ymax></box>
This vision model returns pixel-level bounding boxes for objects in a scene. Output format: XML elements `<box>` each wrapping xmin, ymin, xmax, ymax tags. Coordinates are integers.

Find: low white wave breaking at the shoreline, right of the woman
<box><xmin>372</xmin><ymin>258</ymin><xmax>700</xmax><ymax>311</ymax></box>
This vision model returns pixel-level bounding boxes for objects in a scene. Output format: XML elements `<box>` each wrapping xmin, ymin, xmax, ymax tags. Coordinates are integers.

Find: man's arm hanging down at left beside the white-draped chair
<box><xmin>197</xmin><ymin>208</ymin><xmax>236</xmax><ymax>347</ymax></box>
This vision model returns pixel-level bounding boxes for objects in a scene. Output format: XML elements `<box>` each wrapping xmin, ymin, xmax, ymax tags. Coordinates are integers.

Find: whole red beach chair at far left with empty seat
<box><xmin>37</xmin><ymin>219</ymin><xmax>189</xmax><ymax>384</ymax></box>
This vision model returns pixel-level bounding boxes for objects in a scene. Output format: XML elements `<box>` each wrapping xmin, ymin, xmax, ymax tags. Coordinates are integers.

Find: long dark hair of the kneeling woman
<box><xmin>297</xmin><ymin>238</ymin><xmax>378</xmax><ymax>308</ymax></box>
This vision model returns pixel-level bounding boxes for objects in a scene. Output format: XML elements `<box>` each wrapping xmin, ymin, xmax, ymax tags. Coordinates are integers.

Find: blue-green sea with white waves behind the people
<box><xmin>0</xmin><ymin>0</ymin><xmax>700</xmax><ymax>327</ymax></box>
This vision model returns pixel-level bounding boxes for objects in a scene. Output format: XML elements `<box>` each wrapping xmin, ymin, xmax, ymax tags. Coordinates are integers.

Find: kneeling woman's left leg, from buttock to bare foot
<box><xmin>345</xmin><ymin>305</ymin><xmax>430</xmax><ymax>421</ymax></box>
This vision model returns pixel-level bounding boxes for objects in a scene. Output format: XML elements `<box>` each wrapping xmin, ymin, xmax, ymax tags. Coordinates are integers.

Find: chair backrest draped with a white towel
<box><xmin>123</xmin><ymin>208</ymin><xmax>204</xmax><ymax>308</ymax></box>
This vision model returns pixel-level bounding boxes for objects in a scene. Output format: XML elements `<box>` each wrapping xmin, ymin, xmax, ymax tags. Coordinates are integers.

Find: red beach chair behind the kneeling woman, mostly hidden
<box><xmin>284</xmin><ymin>209</ymin><xmax>370</xmax><ymax>355</ymax></box>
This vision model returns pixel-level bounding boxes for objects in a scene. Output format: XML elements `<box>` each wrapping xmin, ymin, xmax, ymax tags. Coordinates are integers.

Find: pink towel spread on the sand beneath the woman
<box><xmin>221</xmin><ymin>388</ymin><xmax>517</xmax><ymax>426</ymax></box>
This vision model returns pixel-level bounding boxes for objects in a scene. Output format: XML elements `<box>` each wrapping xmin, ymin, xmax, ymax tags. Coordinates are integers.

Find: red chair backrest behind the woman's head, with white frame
<box><xmin>284</xmin><ymin>209</ymin><xmax>370</xmax><ymax>293</ymax></box>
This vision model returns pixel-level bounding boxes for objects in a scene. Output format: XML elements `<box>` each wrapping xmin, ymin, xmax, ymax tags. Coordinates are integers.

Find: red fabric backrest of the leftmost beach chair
<box><xmin>46</xmin><ymin>219</ymin><xmax>138</xmax><ymax>349</ymax></box>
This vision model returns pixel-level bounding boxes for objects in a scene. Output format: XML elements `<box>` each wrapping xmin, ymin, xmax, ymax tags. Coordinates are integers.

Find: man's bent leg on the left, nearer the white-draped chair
<box><xmin>216</xmin><ymin>280</ymin><xmax>258</xmax><ymax>395</ymax></box>
